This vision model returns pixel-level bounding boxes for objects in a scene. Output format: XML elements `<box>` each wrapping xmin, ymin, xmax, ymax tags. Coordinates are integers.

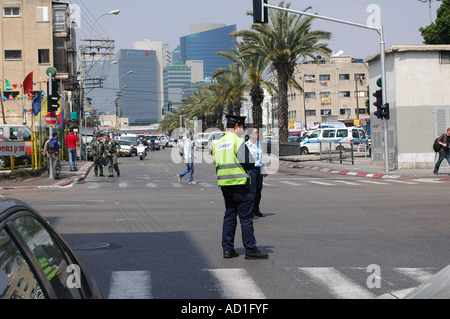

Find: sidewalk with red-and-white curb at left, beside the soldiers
<box><xmin>0</xmin><ymin>161</ymin><xmax>94</xmax><ymax>190</ymax></box>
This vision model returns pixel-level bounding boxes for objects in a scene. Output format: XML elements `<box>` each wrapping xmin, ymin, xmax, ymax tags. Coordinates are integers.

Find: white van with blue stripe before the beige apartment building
<box><xmin>300</xmin><ymin>126</ymin><xmax>368</xmax><ymax>155</ymax></box>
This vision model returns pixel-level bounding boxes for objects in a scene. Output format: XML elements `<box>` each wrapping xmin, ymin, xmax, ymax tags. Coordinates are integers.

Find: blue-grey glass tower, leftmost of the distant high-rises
<box><xmin>117</xmin><ymin>49</ymin><xmax>162</xmax><ymax>126</ymax></box>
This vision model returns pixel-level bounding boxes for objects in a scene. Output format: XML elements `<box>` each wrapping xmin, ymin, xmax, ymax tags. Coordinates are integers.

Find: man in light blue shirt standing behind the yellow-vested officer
<box><xmin>245</xmin><ymin>128</ymin><xmax>265</xmax><ymax>219</ymax></box>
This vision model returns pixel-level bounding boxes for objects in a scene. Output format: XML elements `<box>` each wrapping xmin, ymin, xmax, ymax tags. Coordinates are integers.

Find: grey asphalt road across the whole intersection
<box><xmin>2</xmin><ymin>149</ymin><xmax>450</xmax><ymax>299</ymax></box>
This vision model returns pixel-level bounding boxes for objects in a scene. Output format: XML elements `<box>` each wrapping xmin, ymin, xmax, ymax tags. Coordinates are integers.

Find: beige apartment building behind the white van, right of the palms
<box><xmin>288</xmin><ymin>56</ymin><xmax>370</xmax><ymax>129</ymax></box>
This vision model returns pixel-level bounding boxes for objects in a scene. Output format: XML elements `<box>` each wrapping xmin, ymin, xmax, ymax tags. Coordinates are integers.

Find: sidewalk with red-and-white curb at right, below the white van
<box><xmin>280</xmin><ymin>155</ymin><xmax>450</xmax><ymax>181</ymax></box>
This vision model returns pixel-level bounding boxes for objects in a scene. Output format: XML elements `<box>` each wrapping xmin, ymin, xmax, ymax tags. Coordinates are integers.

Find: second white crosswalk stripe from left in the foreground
<box><xmin>206</xmin><ymin>268</ymin><xmax>266</xmax><ymax>299</ymax></box>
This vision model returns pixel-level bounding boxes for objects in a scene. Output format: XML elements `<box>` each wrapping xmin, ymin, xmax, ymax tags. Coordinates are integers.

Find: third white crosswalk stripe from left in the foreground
<box><xmin>299</xmin><ymin>267</ymin><xmax>376</xmax><ymax>299</ymax></box>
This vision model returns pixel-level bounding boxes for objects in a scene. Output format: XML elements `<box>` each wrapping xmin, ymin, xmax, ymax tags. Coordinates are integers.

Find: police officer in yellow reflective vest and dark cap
<box><xmin>213</xmin><ymin>115</ymin><xmax>269</xmax><ymax>259</ymax></box>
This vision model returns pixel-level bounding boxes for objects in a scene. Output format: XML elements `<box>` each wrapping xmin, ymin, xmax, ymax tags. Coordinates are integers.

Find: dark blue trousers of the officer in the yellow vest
<box><xmin>221</xmin><ymin>185</ymin><xmax>258</xmax><ymax>253</ymax></box>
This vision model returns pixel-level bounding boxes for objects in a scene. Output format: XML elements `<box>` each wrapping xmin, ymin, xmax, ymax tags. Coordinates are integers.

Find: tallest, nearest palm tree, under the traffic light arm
<box><xmin>232</xmin><ymin>1</ymin><xmax>331</xmax><ymax>141</ymax></box>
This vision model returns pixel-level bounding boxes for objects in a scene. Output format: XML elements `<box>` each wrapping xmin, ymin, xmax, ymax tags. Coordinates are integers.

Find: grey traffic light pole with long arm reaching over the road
<box><xmin>262</xmin><ymin>0</ymin><xmax>389</xmax><ymax>173</ymax></box>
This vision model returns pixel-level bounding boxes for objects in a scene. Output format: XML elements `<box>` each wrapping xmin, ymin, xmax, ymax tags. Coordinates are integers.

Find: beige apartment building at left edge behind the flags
<box><xmin>0</xmin><ymin>0</ymin><xmax>77</xmax><ymax>126</ymax></box>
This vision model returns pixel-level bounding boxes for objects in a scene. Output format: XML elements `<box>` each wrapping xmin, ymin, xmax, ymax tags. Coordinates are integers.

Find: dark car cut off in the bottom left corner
<box><xmin>0</xmin><ymin>198</ymin><xmax>103</xmax><ymax>299</ymax></box>
